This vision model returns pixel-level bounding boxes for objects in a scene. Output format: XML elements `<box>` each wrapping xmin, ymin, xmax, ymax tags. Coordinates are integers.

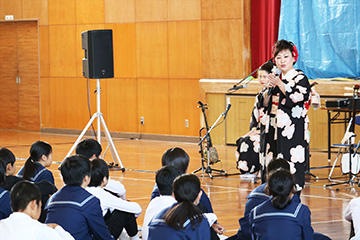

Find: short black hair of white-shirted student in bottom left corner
<box><xmin>10</xmin><ymin>180</ymin><xmax>41</xmax><ymax>212</ymax></box>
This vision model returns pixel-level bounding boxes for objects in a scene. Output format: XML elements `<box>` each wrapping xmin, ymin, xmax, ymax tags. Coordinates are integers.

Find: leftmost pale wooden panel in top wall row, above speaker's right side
<box><xmin>105</xmin><ymin>0</ymin><xmax>135</xmax><ymax>23</ymax></box>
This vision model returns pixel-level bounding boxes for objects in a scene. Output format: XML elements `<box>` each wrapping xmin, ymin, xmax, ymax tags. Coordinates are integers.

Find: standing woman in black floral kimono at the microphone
<box><xmin>259</xmin><ymin>40</ymin><xmax>311</xmax><ymax>191</ymax></box>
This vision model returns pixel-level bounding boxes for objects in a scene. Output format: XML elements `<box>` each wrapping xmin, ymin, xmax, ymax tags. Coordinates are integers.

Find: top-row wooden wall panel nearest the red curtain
<box><xmin>201</xmin><ymin>0</ymin><xmax>245</xmax><ymax>19</ymax></box>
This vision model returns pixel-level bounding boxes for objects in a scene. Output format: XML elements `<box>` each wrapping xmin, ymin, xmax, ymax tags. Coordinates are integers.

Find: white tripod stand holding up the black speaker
<box><xmin>66</xmin><ymin>79</ymin><xmax>125</xmax><ymax>172</ymax></box>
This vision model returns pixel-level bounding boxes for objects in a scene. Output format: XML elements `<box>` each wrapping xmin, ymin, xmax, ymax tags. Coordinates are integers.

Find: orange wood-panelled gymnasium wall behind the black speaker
<box><xmin>0</xmin><ymin>0</ymin><xmax>251</xmax><ymax>136</ymax></box>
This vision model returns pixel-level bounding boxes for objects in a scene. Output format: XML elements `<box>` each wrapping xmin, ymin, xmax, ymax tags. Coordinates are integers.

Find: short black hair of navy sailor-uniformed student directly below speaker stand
<box><xmin>60</xmin><ymin>154</ymin><xmax>91</xmax><ymax>186</ymax></box>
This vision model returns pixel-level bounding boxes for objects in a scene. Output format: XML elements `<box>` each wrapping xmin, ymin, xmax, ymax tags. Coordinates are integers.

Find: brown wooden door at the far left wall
<box><xmin>0</xmin><ymin>21</ymin><xmax>40</xmax><ymax>131</ymax></box>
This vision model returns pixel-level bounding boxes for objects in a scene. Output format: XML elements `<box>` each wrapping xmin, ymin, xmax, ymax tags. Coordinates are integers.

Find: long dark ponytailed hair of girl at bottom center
<box><xmin>164</xmin><ymin>174</ymin><xmax>203</xmax><ymax>230</ymax></box>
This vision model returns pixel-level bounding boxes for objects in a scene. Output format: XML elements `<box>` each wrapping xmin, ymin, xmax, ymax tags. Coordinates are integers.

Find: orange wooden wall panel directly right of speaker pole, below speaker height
<box><xmin>105</xmin><ymin>78</ymin><xmax>140</xmax><ymax>132</ymax></box>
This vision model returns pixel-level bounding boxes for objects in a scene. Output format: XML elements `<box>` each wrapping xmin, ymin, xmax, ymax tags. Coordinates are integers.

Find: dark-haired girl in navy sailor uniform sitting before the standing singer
<box><xmin>249</xmin><ymin>169</ymin><xmax>316</xmax><ymax>240</ymax></box>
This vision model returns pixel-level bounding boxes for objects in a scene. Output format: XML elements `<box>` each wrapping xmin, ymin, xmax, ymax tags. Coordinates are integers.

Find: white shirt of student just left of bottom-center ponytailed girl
<box><xmin>141</xmin><ymin>195</ymin><xmax>176</xmax><ymax>240</ymax></box>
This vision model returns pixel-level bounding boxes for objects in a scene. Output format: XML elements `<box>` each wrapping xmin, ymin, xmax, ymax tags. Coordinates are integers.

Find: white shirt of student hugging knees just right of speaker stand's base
<box><xmin>85</xmin><ymin>187</ymin><xmax>142</xmax><ymax>217</ymax></box>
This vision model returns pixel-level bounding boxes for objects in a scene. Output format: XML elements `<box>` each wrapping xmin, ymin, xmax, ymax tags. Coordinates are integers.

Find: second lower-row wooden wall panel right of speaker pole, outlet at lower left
<box><xmin>138</xmin><ymin>79</ymin><xmax>170</xmax><ymax>134</ymax></box>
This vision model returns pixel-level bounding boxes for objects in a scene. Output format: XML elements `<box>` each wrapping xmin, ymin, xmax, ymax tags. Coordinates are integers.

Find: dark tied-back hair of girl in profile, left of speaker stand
<box><xmin>23</xmin><ymin>141</ymin><xmax>52</xmax><ymax>180</ymax></box>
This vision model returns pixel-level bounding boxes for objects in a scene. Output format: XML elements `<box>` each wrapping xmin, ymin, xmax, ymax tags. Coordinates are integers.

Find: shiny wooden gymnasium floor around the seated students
<box><xmin>0</xmin><ymin>130</ymin><xmax>359</xmax><ymax>240</ymax></box>
